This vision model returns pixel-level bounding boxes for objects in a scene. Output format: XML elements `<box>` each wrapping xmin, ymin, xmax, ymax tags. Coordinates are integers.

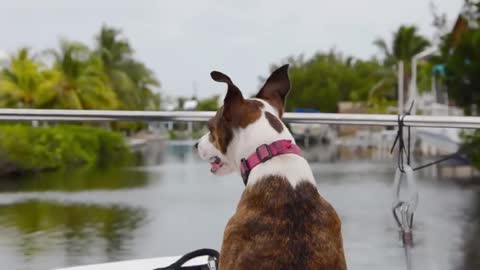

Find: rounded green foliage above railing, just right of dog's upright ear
<box><xmin>266</xmin><ymin>51</ymin><xmax>394</xmax><ymax>112</ymax></box>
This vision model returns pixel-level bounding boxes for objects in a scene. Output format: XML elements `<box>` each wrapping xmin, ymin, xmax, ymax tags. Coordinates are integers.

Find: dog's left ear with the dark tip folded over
<box><xmin>210</xmin><ymin>71</ymin><xmax>244</xmax><ymax>121</ymax></box>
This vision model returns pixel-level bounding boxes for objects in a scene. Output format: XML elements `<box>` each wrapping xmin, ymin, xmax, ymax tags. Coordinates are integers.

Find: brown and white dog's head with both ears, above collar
<box><xmin>197</xmin><ymin>65</ymin><xmax>293</xmax><ymax>175</ymax></box>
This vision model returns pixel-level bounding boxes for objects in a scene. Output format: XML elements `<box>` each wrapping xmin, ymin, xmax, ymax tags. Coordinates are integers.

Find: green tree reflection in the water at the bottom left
<box><xmin>0</xmin><ymin>200</ymin><xmax>147</xmax><ymax>269</ymax></box>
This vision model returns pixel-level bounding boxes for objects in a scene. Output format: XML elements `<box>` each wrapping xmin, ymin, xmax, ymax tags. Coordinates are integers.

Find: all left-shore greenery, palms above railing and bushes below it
<box><xmin>0</xmin><ymin>25</ymin><xmax>161</xmax><ymax>175</ymax></box>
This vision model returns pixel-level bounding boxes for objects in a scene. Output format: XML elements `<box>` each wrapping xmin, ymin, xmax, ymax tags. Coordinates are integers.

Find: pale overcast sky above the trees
<box><xmin>0</xmin><ymin>0</ymin><xmax>463</xmax><ymax>97</ymax></box>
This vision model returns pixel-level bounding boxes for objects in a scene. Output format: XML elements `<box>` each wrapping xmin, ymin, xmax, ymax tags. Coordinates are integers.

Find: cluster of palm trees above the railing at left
<box><xmin>0</xmin><ymin>26</ymin><xmax>161</xmax><ymax>110</ymax></box>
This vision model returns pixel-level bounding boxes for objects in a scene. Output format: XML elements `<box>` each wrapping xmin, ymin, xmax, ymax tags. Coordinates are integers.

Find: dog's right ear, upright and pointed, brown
<box><xmin>256</xmin><ymin>64</ymin><xmax>290</xmax><ymax>117</ymax></box>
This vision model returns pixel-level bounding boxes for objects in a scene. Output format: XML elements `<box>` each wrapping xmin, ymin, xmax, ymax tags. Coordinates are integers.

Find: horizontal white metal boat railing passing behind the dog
<box><xmin>0</xmin><ymin>109</ymin><xmax>480</xmax><ymax>129</ymax></box>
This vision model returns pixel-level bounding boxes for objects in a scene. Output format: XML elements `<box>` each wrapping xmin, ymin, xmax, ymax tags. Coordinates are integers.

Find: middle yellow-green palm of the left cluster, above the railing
<box><xmin>46</xmin><ymin>40</ymin><xmax>119</xmax><ymax>109</ymax></box>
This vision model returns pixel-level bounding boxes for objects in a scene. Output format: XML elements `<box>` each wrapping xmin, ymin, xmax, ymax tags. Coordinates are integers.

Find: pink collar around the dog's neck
<box><xmin>240</xmin><ymin>140</ymin><xmax>303</xmax><ymax>185</ymax></box>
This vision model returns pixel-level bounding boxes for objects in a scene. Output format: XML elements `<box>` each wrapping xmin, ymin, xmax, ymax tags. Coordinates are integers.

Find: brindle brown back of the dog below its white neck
<box><xmin>220</xmin><ymin>176</ymin><xmax>346</xmax><ymax>270</ymax></box>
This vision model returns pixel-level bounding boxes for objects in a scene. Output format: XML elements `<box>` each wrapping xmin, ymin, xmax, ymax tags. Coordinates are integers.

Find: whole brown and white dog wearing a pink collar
<box><xmin>196</xmin><ymin>65</ymin><xmax>346</xmax><ymax>270</ymax></box>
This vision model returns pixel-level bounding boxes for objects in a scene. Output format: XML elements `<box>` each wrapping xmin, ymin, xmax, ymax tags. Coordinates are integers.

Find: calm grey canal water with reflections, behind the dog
<box><xmin>0</xmin><ymin>142</ymin><xmax>480</xmax><ymax>270</ymax></box>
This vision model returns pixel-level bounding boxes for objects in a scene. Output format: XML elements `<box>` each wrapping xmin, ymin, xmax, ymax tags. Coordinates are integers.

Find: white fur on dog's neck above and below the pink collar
<box><xmin>228</xmin><ymin>101</ymin><xmax>315</xmax><ymax>187</ymax></box>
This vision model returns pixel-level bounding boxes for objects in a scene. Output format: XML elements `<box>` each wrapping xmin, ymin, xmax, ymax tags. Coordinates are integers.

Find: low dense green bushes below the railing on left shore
<box><xmin>0</xmin><ymin>124</ymin><xmax>134</xmax><ymax>175</ymax></box>
